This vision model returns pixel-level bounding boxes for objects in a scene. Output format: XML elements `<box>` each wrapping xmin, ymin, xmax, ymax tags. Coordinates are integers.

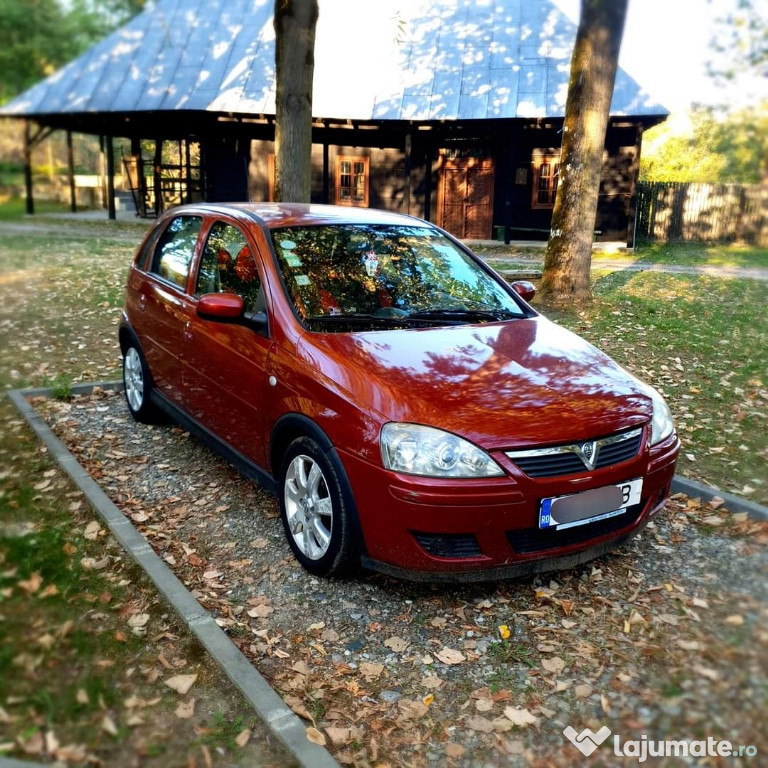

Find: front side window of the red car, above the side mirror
<box><xmin>195</xmin><ymin>221</ymin><xmax>264</xmax><ymax>312</ymax></box>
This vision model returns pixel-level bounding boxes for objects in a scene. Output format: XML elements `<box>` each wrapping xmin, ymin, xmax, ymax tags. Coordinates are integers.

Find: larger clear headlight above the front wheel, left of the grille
<box><xmin>381</xmin><ymin>423</ymin><xmax>504</xmax><ymax>477</ymax></box>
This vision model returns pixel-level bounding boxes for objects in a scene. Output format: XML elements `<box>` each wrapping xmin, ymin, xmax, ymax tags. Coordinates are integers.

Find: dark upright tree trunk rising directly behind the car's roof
<box><xmin>275</xmin><ymin>0</ymin><xmax>318</xmax><ymax>203</ymax></box>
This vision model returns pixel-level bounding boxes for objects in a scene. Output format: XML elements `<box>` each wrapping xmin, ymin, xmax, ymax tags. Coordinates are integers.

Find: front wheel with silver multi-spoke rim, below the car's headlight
<box><xmin>280</xmin><ymin>437</ymin><xmax>359</xmax><ymax>576</ymax></box>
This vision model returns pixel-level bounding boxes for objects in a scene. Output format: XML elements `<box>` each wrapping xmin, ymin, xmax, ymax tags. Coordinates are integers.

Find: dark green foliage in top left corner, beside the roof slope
<box><xmin>0</xmin><ymin>0</ymin><xmax>144</xmax><ymax>104</ymax></box>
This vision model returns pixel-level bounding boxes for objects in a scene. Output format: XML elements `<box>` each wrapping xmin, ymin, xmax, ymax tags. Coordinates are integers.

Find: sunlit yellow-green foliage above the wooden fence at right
<box><xmin>640</xmin><ymin>103</ymin><xmax>768</xmax><ymax>184</ymax></box>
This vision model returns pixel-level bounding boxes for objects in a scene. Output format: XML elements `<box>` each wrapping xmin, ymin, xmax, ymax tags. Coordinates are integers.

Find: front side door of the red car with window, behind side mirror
<box><xmin>182</xmin><ymin>218</ymin><xmax>270</xmax><ymax>466</ymax></box>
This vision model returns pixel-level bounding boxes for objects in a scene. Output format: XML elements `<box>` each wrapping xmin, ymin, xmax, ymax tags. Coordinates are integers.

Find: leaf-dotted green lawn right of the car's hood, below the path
<box><xmin>542</xmin><ymin>271</ymin><xmax>768</xmax><ymax>504</ymax></box>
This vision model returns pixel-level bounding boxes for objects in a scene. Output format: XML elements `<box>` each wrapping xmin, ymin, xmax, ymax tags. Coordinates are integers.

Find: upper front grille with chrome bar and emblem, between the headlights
<box><xmin>507</xmin><ymin>429</ymin><xmax>643</xmax><ymax>477</ymax></box>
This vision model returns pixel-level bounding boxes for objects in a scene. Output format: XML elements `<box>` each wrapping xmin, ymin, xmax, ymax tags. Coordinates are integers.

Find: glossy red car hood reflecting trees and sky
<box><xmin>301</xmin><ymin>317</ymin><xmax>653</xmax><ymax>449</ymax></box>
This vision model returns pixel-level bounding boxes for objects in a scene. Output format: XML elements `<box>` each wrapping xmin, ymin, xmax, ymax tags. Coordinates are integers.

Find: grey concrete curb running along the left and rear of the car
<box><xmin>6</xmin><ymin>382</ymin><xmax>340</xmax><ymax>768</ymax></box>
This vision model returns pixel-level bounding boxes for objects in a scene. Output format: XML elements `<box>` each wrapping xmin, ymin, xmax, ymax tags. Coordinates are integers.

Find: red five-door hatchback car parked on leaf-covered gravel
<box><xmin>120</xmin><ymin>204</ymin><xmax>680</xmax><ymax>579</ymax></box>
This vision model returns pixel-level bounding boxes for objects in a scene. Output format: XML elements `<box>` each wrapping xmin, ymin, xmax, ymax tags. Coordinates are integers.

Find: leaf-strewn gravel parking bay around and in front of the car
<box><xmin>36</xmin><ymin>392</ymin><xmax>768</xmax><ymax>766</ymax></box>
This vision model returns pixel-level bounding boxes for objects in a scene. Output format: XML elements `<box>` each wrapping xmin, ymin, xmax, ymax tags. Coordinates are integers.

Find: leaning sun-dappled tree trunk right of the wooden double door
<box><xmin>541</xmin><ymin>0</ymin><xmax>628</xmax><ymax>305</ymax></box>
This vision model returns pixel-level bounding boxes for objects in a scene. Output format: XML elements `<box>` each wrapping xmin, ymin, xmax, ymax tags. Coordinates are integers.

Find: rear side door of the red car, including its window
<box><xmin>131</xmin><ymin>215</ymin><xmax>203</xmax><ymax>405</ymax></box>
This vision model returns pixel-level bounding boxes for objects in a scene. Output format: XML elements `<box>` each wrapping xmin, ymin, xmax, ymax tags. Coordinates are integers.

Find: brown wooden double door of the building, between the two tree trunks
<box><xmin>438</xmin><ymin>157</ymin><xmax>494</xmax><ymax>240</ymax></box>
